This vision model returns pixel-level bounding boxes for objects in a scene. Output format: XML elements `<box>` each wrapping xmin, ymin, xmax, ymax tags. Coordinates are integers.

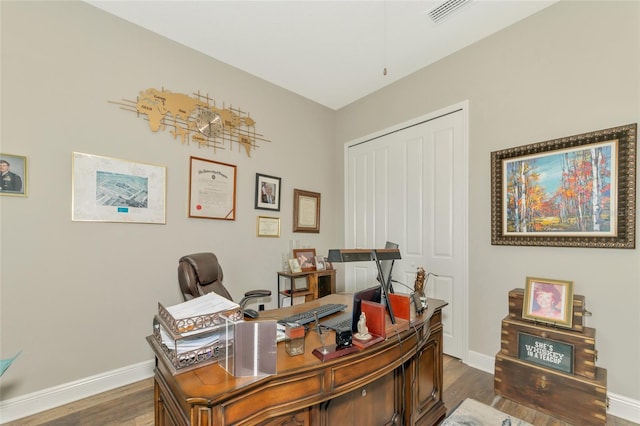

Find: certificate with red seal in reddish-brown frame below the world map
<box><xmin>189</xmin><ymin>157</ymin><xmax>237</xmax><ymax>220</ymax></box>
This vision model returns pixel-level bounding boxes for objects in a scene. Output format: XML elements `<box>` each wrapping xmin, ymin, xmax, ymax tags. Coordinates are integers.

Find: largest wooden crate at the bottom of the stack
<box><xmin>494</xmin><ymin>353</ymin><xmax>607</xmax><ymax>426</ymax></box>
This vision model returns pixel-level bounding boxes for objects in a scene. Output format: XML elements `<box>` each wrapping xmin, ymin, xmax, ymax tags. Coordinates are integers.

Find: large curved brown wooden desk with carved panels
<box><xmin>154</xmin><ymin>294</ymin><xmax>446</xmax><ymax>426</ymax></box>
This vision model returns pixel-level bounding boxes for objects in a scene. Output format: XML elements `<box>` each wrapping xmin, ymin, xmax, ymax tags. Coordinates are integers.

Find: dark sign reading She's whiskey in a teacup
<box><xmin>518</xmin><ymin>333</ymin><xmax>573</xmax><ymax>374</ymax></box>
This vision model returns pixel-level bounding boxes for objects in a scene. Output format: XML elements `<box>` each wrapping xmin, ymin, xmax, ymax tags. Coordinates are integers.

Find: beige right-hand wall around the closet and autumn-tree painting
<box><xmin>336</xmin><ymin>1</ymin><xmax>640</xmax><ymax>400</ymax></box>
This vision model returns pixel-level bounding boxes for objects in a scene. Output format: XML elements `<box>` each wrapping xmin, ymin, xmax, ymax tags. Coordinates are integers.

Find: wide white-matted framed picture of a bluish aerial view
<box><xmin>71</xmin><ymin>152</ymin><xmax>167</xmax><ymax>224</ymax></box>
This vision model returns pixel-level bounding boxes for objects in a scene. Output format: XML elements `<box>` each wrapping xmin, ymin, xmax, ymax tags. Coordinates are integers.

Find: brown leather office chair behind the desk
<box><xmin>178</xmin><ymin>253</ymin><xmax>271</xmax><ymax>318</ymax></box>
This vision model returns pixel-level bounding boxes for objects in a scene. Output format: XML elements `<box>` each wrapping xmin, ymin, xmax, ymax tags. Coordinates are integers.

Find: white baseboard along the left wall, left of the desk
<box><xmin>0</xmin><ymin>361</ymin><xmax>155</xmax><ymax>424</ymax></box>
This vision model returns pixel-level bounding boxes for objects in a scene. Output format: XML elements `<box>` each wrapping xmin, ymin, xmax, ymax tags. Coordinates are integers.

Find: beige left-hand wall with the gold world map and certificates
<box><xmin>0</xmin><ymin>1</ymin><xmax>341</xmax><ymax>400</ymax></box>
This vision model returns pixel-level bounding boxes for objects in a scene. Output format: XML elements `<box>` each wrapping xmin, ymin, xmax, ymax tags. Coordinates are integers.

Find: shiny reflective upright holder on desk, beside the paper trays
<box><xmin>219</xmin><ymin>320</ymin><xmax>278</xmax><ymax>377</ymax></box>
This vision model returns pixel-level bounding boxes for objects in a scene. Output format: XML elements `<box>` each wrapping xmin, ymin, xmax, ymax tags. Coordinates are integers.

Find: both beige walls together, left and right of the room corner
<box><xmin>0</xmin><ymin>1</ymin><xmax>640</xmax><ymax>416</ymax></box>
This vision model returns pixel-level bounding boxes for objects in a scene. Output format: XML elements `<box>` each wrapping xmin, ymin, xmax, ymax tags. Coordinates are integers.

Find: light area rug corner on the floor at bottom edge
<box><xmin>440</xmin><ymin>398</ymin><xmax>533</xmax><ymax>426</ymax></box>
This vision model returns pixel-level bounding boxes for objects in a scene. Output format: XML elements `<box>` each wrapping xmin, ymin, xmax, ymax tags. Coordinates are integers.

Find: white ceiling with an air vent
<box><xmin>87</xmin><ymin>0</ymin><xmax>557</xmax><ymax>109</ymax></box>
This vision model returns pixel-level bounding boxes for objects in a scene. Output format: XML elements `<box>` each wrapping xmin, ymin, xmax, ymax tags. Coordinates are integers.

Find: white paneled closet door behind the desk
<box><xmin>344</xmin><ymin>107</ymin><xmax>468</xmax><ymax>358</ymax></box>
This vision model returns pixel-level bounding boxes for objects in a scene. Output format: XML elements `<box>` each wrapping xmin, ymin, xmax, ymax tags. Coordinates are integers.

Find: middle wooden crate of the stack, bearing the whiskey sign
<box><xmin>500</xmin><ymin>316</ymin><xmax>598</xmax><ymax>379</ymax></box>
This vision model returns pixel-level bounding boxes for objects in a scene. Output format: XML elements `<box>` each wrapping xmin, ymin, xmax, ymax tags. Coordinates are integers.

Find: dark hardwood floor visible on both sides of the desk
<box><xmin>6</xmin><ymin>356</ymin><xmax>637</xmax><ymax>426</ymax></box>
